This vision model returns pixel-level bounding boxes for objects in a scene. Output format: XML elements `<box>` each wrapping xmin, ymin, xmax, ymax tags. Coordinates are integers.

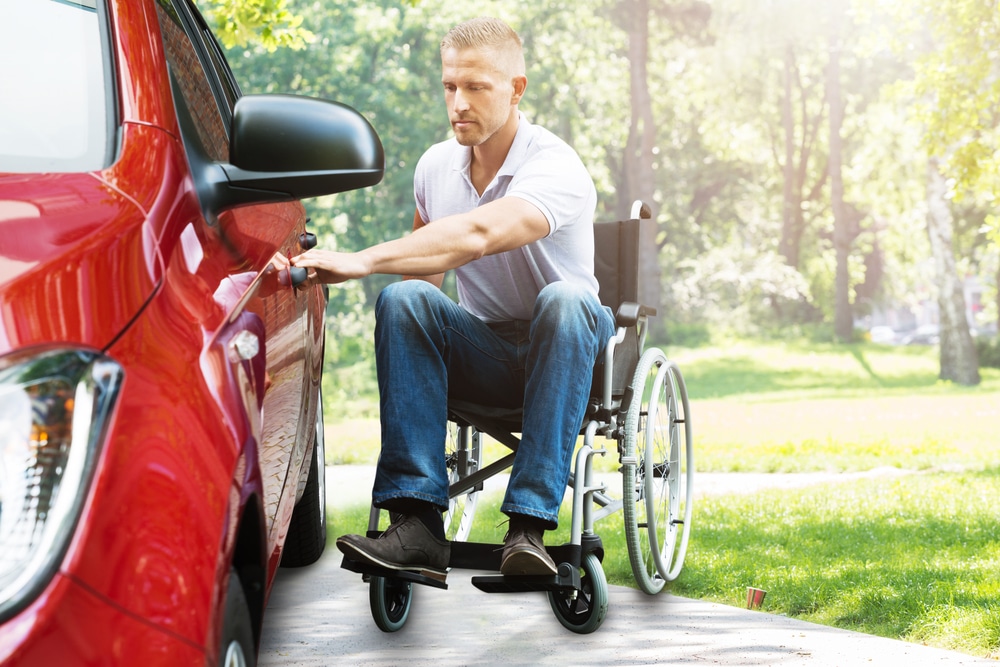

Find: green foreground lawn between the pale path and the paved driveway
<box><xmin>672</xmin><ymin>468</ymin><xmax>1000</xmax><ymax>656</ymax></box>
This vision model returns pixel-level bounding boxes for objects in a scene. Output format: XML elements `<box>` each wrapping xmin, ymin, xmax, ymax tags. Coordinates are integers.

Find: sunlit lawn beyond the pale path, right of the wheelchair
<box><xmin>671</xmin><ymin>342</ymin><xmax>1000</xmax><ymax>472</ymax></box>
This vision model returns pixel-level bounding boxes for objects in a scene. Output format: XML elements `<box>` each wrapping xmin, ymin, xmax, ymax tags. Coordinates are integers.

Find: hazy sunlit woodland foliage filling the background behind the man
<box><xmin>215</xmin><ymin>0</ymin><xmax>1000</xmax><ymax>366</ymax></box>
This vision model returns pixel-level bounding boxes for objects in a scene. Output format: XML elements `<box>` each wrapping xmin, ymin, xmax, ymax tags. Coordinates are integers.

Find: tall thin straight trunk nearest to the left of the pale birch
<box><xmin>826</xmin><ymin>8</ymin><xmax>857</xmax><ymax>342</ymax></box>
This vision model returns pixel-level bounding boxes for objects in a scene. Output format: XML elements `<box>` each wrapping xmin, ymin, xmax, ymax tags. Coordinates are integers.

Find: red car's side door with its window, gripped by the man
<box><xmin>158</xmin><ymin>0</ymin><xmax>322</xmax><ymax>556</ymax></box>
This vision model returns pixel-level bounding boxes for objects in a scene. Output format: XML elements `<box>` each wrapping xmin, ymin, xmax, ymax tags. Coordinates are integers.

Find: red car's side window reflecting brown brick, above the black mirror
<box><xmin>157</xmin><ymin>0</ymin><xmax>231</xmax><ymax>162</ymax></box>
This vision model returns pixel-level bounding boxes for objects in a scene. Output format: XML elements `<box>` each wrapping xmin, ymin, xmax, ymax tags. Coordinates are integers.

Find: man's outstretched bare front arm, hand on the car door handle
<box><xmin>291</xmin><ymin>197</ymin><xmax>549</xmax><ymax>283</ymax></box>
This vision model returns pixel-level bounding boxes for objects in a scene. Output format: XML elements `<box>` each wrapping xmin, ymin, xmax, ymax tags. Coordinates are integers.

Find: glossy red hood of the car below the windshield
<box><xmin>0</xmin><ymin>125</ymin><xmax>174</xmax><ymax>354</ymax></box>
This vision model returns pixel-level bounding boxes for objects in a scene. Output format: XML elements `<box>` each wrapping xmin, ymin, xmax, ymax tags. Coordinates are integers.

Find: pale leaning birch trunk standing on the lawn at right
<box><xmin>927</xmin><ymin>158</ymin><xmax>980</xmax><ymax>385</ymax></box>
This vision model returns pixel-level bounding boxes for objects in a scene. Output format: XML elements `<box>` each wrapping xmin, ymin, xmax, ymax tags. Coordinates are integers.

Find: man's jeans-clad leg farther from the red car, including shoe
<box><xmin>500</xmin><ymin>283</ymin><xmax>614</xmax><ymax>574</ymax></box>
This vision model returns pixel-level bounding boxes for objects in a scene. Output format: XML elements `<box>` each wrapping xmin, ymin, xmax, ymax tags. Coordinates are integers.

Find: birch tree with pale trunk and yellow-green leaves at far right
<box><xmin>888</xmin><ymin>0</ymin><xmax>1000</xmax><ymax>385</ymax></box>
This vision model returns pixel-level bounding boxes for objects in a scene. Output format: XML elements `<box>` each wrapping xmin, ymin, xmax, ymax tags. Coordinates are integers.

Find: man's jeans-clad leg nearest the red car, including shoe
<box><xmin>337</xmin><ymin>280</ymin><xmax>523</xmax><ymax>577</ymax></box>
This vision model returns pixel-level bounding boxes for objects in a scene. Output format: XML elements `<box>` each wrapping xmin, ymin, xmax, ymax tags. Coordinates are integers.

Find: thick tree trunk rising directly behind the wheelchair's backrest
<box><xmin>618</xmin><ymin>0</ymin><xmax>664</xmax><ymax>318</ymax></box>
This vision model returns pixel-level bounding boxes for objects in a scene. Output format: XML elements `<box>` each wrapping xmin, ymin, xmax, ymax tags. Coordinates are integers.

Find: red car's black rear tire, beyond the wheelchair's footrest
<box><xmin>281</xmin><ymin>397</ymin><xmax>326</xmax><ymax>567</ymax></box>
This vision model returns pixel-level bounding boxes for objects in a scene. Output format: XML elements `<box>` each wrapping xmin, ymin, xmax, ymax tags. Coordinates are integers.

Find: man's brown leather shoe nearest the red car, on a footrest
<box><xmin>337</xmin><ymin>516</ymin><xmax>451</xmax><ymax>581</ymax></box>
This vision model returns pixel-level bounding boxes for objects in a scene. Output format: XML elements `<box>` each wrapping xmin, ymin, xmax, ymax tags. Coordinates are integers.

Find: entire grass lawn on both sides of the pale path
<box><xmin>327</xmin><ymin>342</ymin><xmax>1000</xmax><ymax>658</ymax></box>
